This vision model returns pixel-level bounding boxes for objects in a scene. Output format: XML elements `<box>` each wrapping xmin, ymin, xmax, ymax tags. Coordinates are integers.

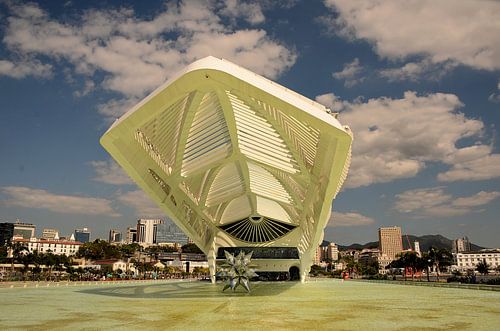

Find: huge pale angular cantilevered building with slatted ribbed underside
<box><xmin>101</xmin><ymin>57</ymin><xmax>352</xmax><ymax>281</ymax></box>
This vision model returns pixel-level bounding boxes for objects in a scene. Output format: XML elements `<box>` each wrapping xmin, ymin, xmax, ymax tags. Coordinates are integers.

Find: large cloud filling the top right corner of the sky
<box><xmin>323</xmin><ymin>0</ymin><xmax>500</xmax><ymax>75</ymax></box>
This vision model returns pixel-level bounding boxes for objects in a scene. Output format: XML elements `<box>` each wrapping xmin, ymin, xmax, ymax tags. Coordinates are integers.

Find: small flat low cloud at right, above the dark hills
<box><xmin>394</xmin><ymin>187</ymin><xmax>500</xmax><ymax>218</ymax></box>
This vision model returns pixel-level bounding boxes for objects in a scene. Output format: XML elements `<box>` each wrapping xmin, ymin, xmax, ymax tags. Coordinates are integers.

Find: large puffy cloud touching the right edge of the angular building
<box><xmin>316</xmin><ymin>91</ymin><xmax>500</xmax><ymax>188</ymax></box>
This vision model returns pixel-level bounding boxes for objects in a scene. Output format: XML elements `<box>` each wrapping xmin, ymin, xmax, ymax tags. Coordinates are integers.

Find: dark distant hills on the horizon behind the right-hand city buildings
<box><xmin>330</xmin><ymin>234</ymin><xmax>484</xmax><ymax>252</ymax></box>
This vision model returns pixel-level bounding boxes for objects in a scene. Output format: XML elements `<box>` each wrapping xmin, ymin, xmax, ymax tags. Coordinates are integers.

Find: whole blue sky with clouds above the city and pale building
<box><xmin>0</xmin><ymin>0</ymin><xmax>500</xmax><ymax>247</ymax></box>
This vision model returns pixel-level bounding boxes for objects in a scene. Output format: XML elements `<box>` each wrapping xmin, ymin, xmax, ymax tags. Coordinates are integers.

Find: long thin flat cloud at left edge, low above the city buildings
<box><xmin>0</xmin><ymin>186</ymin><xmax>120</xmax><ymax>217</ymax></box>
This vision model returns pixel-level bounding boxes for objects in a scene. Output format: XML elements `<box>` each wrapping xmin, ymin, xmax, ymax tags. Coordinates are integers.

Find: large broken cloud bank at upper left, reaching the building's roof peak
<box><xmin>0</xmin><ymin>1</ymin><xmax>296</xmax><ymax>116</ymax></box>
